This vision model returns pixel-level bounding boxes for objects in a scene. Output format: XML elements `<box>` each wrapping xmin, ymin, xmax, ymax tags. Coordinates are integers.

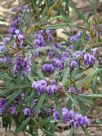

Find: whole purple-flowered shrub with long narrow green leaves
<box><xmin>0</xmin><ymin>4</ymin><xmax>102</xmax><ymax>136</ymax></box>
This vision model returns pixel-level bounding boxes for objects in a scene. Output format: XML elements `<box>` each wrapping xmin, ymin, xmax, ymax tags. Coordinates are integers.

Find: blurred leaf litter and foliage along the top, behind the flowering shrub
<box><xmin>0</xmin><ymin>0</ymin><xmax>102</xmax><ymax>35</ymax></box>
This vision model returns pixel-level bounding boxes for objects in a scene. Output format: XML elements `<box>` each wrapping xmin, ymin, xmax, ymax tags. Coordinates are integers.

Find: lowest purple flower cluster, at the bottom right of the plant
<box><xmin>52</xmin><ymin>108</ymin><xmax>90</xmax><ymax>128</ymax></box>
